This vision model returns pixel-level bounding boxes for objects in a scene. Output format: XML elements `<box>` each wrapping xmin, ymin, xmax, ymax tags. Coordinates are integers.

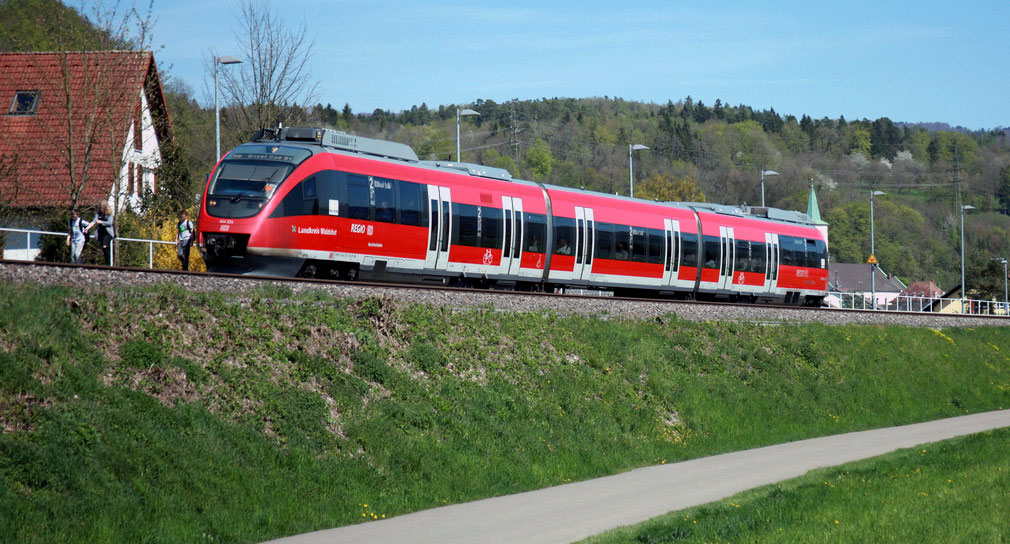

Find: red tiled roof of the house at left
<box><xmin>0</xmin><ymin>51</ymin><xmax>165</xmax><ymax>207</ymax></box>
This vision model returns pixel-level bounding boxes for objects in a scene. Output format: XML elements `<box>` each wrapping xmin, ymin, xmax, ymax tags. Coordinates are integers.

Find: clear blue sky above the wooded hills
<box><xmin>124</xmin><ymin>0</ymin><xmax>1010</xmax><ymax>128</ymax></box>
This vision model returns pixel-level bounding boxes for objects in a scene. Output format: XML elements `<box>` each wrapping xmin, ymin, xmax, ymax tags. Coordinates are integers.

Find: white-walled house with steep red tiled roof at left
<box><xmin>0</xmin><ymin>50</ymin><xmax>171</xmax><ymax>256</ymax></box>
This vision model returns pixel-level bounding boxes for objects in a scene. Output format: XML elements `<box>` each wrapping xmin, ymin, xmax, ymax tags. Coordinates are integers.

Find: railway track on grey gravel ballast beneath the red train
<box><xmin>0</xmin><ymin>260</ymin><xmax>1010</xmax><ymax>328</ymax></box>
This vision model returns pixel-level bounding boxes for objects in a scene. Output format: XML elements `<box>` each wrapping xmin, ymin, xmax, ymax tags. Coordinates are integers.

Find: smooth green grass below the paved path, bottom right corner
<box><xmin>583</xmin><ymin>429</ymin><xmax>1010</xmax><ymax>544</ymax></box>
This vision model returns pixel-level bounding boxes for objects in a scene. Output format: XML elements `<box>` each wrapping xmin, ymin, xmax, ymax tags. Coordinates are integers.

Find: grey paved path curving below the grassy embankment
<box><xmin>266</xmin><ymin>410</ymin><xmax>1010</xmax><ymax>544</ymax></box>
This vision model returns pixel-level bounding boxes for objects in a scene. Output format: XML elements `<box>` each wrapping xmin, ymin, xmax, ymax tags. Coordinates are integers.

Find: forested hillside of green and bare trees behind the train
<box><xmin>0</xmin><ymin>0</ymin><xmax>1010</xmax><ymax>298</ymax></box>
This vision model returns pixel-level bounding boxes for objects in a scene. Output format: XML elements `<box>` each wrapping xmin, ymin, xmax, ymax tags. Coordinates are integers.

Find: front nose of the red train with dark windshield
<box><xmin>197</xmin><ymin>129</ymin><xmax>313</xmax><ymax>277</ymax></box>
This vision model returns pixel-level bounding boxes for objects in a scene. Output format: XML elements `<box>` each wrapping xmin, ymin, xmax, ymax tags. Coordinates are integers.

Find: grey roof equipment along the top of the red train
<box><xmin>244</xmin><ymin>127</ymin><xmax>816</xmax><ymax>226</ymax></box>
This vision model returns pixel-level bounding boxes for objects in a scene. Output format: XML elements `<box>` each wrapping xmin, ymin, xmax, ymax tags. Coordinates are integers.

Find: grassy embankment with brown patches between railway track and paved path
<box><xmin>0</xmin><ymin>285</ymin><xmax>1010</xmax><ymax>542</ymax></box>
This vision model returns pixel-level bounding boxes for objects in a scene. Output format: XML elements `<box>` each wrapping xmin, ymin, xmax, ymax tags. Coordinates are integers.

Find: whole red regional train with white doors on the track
<box><xmin>197</xmin><ymin>127</ymin><xmax>827</xmax><ymax>304</ymax></box>
